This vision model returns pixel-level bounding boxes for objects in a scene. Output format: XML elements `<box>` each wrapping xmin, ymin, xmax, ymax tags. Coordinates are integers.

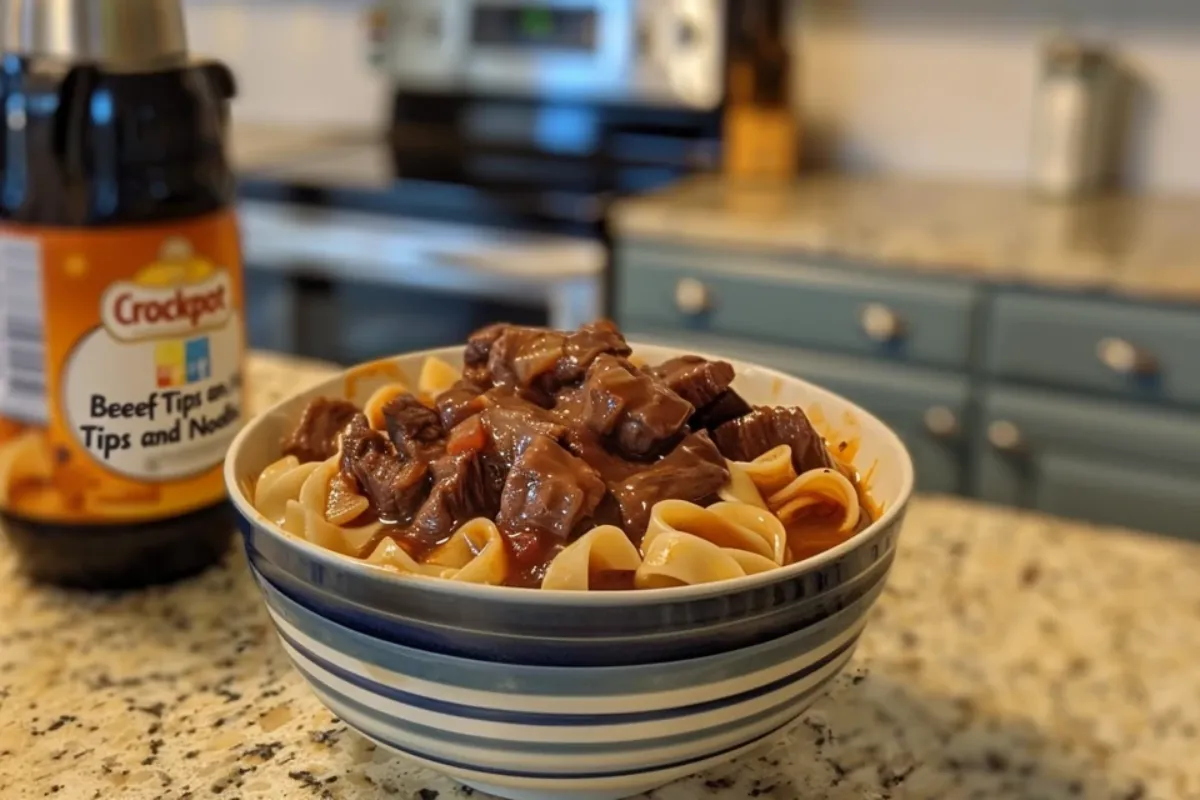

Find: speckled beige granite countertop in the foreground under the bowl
<box><xmin>0</xmin><ymin>356</ymin><xmax>1200</xmax><ymax>800</ymax></box>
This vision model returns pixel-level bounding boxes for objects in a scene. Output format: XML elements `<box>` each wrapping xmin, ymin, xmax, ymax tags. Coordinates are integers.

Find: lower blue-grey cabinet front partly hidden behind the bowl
<box><xmin>630</xmin><ymin>330</ymin><xmax>971</xmax><ymax>493</ymax></box>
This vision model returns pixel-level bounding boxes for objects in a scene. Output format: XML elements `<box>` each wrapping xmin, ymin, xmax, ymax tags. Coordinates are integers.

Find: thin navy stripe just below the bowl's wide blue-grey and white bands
<box><xmin>268</xmin><ymin>618</ymin><xmax>858</xmax><ymax>728</ymax></box>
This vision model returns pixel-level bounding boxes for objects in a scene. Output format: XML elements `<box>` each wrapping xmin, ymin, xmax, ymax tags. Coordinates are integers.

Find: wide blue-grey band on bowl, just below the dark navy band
<box><xmin>254</xmin><ymin>572</ymin><xmax>883</xmax><ymax>699</ymax></box>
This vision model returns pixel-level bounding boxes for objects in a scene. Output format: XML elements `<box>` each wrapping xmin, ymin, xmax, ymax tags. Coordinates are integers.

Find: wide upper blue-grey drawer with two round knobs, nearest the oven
<box><xmin>616</xmin><ymin>245</ymin><xmax>977</xmax><ymax>367</ymax></box>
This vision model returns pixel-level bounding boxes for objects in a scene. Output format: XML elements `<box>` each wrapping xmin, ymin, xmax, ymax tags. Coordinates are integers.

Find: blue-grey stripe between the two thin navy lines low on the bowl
<box><xmin>296</xmin><ymin>662</ymin><xmax>840</xmax><ymax>769</ymax></box>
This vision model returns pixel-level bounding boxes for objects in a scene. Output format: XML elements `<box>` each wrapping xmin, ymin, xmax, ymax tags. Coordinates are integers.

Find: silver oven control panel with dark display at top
<box><xmin>371</xmin><ymin>0</ymin><xmax>727</xmax><ymax>109</ymax></box>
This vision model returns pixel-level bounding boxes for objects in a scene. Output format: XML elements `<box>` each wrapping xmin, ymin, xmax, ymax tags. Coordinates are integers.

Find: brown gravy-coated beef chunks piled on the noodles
<box><xmin>286</xmin><ymin>323</ymin><xmax>875</xmax><ymax>590</ymax></box>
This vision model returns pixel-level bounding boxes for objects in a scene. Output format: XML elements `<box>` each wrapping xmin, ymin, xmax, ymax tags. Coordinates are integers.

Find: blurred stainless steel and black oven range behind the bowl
<box><xmin>241</xmin><ymin>0</ymin><xmax>727</xmax><ymax>362</ymax></box>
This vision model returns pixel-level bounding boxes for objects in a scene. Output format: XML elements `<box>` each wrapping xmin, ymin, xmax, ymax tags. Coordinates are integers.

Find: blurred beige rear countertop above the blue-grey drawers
<box><xmin>616</xmin><ymin>176</ymin><xmax>1200</xmax><ymax>302</ymax></box>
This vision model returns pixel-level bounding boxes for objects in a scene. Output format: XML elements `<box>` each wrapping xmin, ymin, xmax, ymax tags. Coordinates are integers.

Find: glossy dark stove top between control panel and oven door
<box><xmin>240</xmin><ymin>91</ymin><xmax>720</xmax><ymax>237</ymax></box>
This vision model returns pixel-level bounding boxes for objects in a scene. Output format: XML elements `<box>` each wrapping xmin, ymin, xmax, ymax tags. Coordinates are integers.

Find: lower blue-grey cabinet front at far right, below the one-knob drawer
<box><xmin>973</xmin><ymin>387</ymin><xmax>1200</xmax><ymax>539</ymax></box>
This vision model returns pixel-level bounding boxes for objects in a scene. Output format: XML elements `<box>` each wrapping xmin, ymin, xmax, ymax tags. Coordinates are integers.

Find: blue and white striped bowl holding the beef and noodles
<box><xmin>226</xmin><ymin>347</ymin><xmax>912</xmax><ymax>800</ymax></box>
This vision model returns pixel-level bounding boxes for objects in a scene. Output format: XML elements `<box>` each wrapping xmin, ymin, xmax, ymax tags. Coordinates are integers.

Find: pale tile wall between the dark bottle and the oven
<box><xmin>185</xmin><ymin>0</ymin><xmax>386</xmax><ymax>127</ymax></box>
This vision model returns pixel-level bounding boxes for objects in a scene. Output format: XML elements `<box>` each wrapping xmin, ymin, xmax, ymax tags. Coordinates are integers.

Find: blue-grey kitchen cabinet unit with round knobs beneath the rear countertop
<box><xmin>613</xmin><ymin>240</ymin><xmax>1200</xmax><ymax>539</ymax></box>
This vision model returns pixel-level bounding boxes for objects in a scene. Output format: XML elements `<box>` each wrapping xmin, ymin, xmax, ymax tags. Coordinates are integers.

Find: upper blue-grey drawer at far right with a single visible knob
<box><xmin>988</xmin><ymin>293</ymin><xmax>1200</xmax><ymax>404</ymax></box>
